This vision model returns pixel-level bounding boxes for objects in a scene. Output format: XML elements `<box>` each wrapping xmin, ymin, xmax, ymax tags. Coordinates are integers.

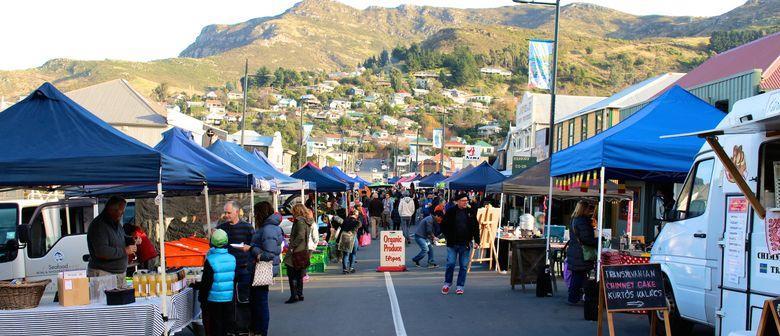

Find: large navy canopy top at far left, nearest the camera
<box><xmin>0</xmin><ymin>83</ymin><xmax>205</xmax><ymax>187</ymax></box>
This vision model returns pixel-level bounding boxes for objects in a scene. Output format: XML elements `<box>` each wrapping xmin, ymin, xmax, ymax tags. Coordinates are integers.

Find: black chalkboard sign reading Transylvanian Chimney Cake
<box><xmin>601</xmin><ymin>264</ymin><xmax>669</xmax><ymax>312</ymax></box>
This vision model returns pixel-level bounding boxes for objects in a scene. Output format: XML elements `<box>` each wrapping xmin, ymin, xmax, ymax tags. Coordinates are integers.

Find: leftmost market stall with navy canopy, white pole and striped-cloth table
<box><xmin>0</xmin><ymin>83</ymin><xmax>206</xmax><ymax>334</ymax></box>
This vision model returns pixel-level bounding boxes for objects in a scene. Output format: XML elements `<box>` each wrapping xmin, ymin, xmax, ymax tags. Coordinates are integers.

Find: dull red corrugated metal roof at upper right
<box><xmin>664</xmin><ymin>32</ymin><xmax>780</xmax><ymax>91</ymax></box>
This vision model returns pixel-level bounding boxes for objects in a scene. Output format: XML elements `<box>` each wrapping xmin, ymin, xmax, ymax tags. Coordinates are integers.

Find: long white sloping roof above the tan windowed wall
<box><xmin>560</xmin><ymin>72</ymin><xmax>685</xmax><ymax>121</ymax></box>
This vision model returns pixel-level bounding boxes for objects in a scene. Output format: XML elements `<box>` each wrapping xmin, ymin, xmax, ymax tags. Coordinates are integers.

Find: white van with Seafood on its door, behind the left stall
<box><xmin>0</xmin><ymin>199</ymin><xmax>98</xmax><ymax>302</ymax></box>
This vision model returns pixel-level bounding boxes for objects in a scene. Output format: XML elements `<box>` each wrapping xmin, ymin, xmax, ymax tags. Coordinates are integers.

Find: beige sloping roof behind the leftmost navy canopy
<box><xmin>65</xmin><ymin>79</ymin><xmax>168</xmax><ymax>127</ymax></box>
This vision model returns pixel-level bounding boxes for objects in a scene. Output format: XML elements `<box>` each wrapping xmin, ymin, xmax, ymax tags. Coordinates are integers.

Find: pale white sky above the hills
<box><xmin>0</xmin><ymin>0</ymin><xmax>745</xmax><ymax>70</ymax></box>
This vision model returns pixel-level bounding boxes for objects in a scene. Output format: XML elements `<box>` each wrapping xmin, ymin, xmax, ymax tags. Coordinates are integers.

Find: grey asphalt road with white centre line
<box><xmin>184</xmin><ymin>230</ymin><xmax>713</xmax><ymax>336</ymax></box>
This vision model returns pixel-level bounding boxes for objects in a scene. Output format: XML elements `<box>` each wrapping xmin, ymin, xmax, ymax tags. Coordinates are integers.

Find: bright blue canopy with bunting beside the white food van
<box><xmin>551</xmin><ymin>86</ymin><xmax>726</xmax><ymax>182</ymax></box>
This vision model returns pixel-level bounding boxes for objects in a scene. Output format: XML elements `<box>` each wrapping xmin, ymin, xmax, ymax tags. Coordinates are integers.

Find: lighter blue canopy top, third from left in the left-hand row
<box><xmin>208</xmin><ymin>139</ymin><xmax>311</xmax><ymax>190</ymax></box>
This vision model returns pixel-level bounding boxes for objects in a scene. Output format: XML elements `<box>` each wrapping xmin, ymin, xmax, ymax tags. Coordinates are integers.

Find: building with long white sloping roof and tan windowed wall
<box><xmin>555</xmin><ymin>73</ymin><xmax>685</xmax><ymax>151</ymax></box>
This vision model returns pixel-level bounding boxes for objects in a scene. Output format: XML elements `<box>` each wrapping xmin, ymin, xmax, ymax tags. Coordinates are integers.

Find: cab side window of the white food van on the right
<box><xmin>676</xmin><ymin>159</ymin><xmax>715</xmax><ymax>219</ymax></box>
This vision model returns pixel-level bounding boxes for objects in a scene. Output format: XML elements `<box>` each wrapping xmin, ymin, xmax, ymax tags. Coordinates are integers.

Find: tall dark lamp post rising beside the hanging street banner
<box><xmin>512</xmin><ymin>0</ymin><xmax>556</xmax><ymax>276</ymax></box>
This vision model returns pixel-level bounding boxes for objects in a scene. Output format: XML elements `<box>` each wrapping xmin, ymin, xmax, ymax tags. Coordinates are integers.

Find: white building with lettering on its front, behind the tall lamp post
<box><xmin>506</xmin><ymin>92</ymin><xmax>605</xmax><ymax>167</ymax></box>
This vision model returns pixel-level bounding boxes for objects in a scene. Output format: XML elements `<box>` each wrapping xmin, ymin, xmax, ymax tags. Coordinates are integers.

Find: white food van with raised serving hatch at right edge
<box><xmin>651</xmin><ymin>90</ymin><xmax>780</xmax><ymax>336</ymax></box>
